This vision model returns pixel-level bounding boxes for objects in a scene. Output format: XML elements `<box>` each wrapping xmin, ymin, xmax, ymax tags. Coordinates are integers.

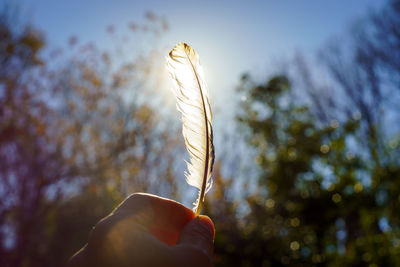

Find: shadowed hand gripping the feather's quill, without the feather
<box><xmin>68</xmin><ymin>194</ymin><xmax>214</xmax><ymax>267</ymax></box>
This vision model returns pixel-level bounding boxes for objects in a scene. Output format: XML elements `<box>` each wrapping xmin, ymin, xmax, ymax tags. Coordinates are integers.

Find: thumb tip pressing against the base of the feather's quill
<box><xmin>178</xmin><ymin>215</ymin><xmax>215</xmax><ymax>258</ymax></box>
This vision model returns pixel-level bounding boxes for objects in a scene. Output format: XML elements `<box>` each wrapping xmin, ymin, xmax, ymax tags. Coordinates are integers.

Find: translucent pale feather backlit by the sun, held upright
<box><xmin>167</xmin><ymin>43</ymin><xmax>214</xmax><ymax>215</ymax></box>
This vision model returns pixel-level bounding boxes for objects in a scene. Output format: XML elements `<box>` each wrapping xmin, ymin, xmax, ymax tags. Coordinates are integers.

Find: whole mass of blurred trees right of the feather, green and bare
<box><xmin>208</xmin><ymin>0</ymin><xmax>400</xmax><ymax>266</ymax></box>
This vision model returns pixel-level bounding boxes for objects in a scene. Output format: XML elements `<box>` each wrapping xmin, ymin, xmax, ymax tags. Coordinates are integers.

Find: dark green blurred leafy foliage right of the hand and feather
<box><xmin>211</xmin><ymin>73</ymin><xmax>400</xmax><ymax>266</ymax></box>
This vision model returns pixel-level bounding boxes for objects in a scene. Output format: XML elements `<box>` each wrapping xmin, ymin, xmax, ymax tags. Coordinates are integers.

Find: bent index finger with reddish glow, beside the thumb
<box><xmin>114</xmin><ymin>193</ymin><xmax>195</xmax><ymax>245</ymax></box>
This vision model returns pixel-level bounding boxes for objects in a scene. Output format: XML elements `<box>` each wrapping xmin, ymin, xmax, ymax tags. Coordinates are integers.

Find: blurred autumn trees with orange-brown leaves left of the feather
<box><xmin>0</xmin><ymin>7</ymin><xmax>183</xmax><ymax>266</ymax></box>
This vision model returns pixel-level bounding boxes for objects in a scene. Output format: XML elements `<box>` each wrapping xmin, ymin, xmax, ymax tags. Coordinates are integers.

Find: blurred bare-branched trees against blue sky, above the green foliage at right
<box><xmin>296</xmin><ymin>0</ymin><xmax>400</xmax><ymax>165</ymax></box>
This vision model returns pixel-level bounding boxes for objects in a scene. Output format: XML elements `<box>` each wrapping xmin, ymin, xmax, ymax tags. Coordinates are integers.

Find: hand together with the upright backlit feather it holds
<box><xmin>68</xmin><ymin>43</ymin><xmax>215</xmax><ymax>267</ymax></box>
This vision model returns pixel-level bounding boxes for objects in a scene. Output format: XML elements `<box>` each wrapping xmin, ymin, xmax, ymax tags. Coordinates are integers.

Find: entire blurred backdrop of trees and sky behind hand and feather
<box><xmin>0</xmin><ymin>0</ymin><xmax>400</xmax><ymax>267</ymax></box>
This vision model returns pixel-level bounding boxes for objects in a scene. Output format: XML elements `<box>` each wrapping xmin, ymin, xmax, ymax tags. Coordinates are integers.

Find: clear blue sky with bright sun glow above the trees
<box><xmin>14</xmin><ymin>0</ymin><xmax>383</xmax><ymax>102</ymax></box>
